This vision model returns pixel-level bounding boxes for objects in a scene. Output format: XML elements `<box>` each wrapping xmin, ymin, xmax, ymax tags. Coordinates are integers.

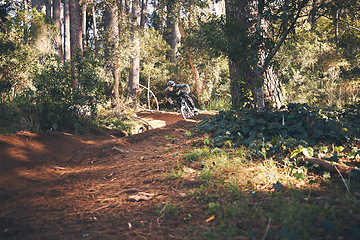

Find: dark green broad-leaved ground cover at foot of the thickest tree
<box><xmin>197</xmin><ymin>103</ymin><xmax>359</xmax><ymax>146</ymax></box>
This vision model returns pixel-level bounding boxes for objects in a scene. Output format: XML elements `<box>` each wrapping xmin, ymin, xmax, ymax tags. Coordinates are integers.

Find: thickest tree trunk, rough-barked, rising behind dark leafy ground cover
<box><xmin>225</xmin><ymin>0</ymin><xmax>284</xmax><ymax>111</ymax></box>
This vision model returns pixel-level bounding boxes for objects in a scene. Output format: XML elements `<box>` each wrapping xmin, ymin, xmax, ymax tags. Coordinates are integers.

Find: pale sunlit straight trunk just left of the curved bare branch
<box><xmin>129</xmin><ymin>0</ymin><xmax>141</xmax><ymax>100</ymax></box>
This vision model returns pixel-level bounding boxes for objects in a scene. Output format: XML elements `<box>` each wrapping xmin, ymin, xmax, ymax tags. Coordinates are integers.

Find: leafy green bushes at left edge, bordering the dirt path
<box><xmin>0</xmin><ymin>49</ymin><xmax>103</xmax><ymax>133</ymax></box>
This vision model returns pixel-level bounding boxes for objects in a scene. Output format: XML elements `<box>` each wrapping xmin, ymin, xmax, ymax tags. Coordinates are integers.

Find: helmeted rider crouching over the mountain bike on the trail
<box><xmin>165</xmin><ymin>81</ymin><xmax>199</xmax><ymax>114</ymax></box>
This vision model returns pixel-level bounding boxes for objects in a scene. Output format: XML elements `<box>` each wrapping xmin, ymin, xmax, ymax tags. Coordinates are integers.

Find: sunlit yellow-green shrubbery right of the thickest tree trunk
<box><xmin>275</xmin><ymin>13</ymin><xmax>360</xmax><ymax>109</ymax></box>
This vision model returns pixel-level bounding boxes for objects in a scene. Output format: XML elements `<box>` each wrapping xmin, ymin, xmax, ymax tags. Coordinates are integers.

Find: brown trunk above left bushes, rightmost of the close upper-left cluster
<box><xmin>70</xmin><ymin>0</ymin><xmax>83</xmax><ymax>88</ymax></box>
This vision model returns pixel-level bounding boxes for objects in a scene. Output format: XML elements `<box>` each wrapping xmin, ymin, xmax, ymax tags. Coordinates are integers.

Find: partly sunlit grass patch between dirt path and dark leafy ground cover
<box><xmin>175</xmin><ymin>143</ymin><xmax>360</xmax><ymax>239</ymax></box>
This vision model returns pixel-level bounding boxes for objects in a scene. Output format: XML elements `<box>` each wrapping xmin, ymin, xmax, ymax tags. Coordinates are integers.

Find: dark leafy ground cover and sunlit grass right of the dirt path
<box><xmin>164</xmin><ymin>104</ymin><xmax>360</xmax><ymax>239</ymax></box>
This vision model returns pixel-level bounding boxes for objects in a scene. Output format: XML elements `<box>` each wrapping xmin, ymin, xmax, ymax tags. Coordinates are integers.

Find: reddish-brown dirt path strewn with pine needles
<box><xmin>0</xmin><ymin>113</ymin><xmax>212</xmax><ymax>239</ymax></box>
